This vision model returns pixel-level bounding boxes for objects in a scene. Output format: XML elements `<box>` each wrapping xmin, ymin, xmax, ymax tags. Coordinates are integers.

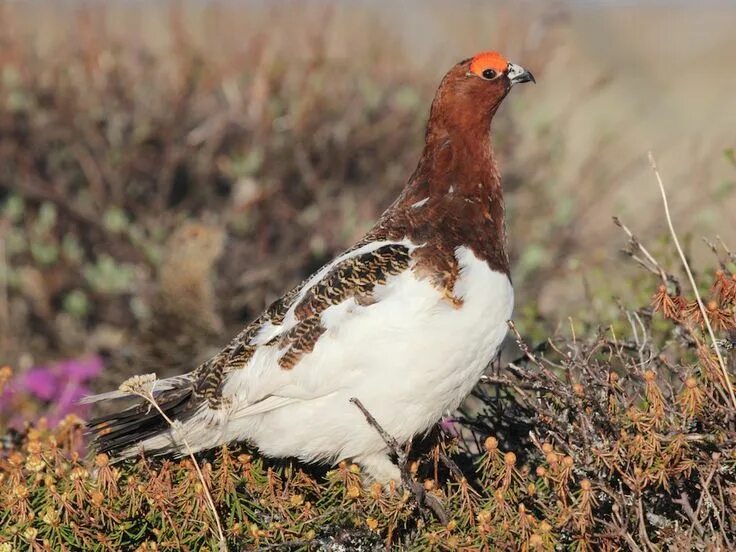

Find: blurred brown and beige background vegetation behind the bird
<box><xmin>0</xmin><ymin>0</ymin><xmax>736</xmax><ymax>420</ymax></box>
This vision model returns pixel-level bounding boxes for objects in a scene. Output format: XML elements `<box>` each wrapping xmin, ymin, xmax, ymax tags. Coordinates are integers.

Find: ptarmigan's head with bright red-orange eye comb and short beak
<box><xmin>432</xmin><ymin>52</ymin><xmax>536</xmax><ymax>133</ymax></box>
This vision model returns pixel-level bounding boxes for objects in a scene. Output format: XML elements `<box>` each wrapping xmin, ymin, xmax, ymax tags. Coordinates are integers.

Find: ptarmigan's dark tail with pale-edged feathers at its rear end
<box><xmin>81</xmin><ymin>375</ymin><xmax>201</xmax><ymax>460</ymax></box>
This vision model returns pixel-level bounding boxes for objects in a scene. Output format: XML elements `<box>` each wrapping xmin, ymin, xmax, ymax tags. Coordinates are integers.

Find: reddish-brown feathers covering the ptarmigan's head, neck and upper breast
<box><xmin>364</xmin><ymin>54</ymin><xmax>524</xmax><ymax>298</ymax></box>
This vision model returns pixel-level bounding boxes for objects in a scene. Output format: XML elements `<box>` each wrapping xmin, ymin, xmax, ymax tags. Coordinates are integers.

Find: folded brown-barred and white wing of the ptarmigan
<box><xmin>193</xmin><ymin>240</ymin><xmax>416</xmax><ymax>415</ymax></box>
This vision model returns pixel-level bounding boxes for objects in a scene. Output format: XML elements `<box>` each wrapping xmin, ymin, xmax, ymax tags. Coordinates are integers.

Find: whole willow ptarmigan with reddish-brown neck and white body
<box><xmin>88</xmin><ymin>52</ymin><xmax>534</xmax><ymax>482</ymax></box>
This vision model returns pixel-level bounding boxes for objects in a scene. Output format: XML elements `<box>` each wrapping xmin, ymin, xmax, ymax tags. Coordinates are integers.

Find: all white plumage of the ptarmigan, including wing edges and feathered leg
<box><xmin>122</xmin><ymin>246</ymin><xmax>513</xmax><ymax>481</ymax></box>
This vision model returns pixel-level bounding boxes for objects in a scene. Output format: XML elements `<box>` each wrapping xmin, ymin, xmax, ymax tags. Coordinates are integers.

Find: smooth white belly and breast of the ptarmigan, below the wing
<box><xmin>226</xmin><ymin>247</ymin><xmax>514</xmax><ymax>460</ymax></box>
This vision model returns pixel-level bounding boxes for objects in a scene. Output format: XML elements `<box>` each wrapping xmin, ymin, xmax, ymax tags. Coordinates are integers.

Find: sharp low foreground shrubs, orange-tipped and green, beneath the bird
<box><xmin>0</xmin><ymin>231</ymin><xmax>736</xmax><ymax>550</ymax></box>
